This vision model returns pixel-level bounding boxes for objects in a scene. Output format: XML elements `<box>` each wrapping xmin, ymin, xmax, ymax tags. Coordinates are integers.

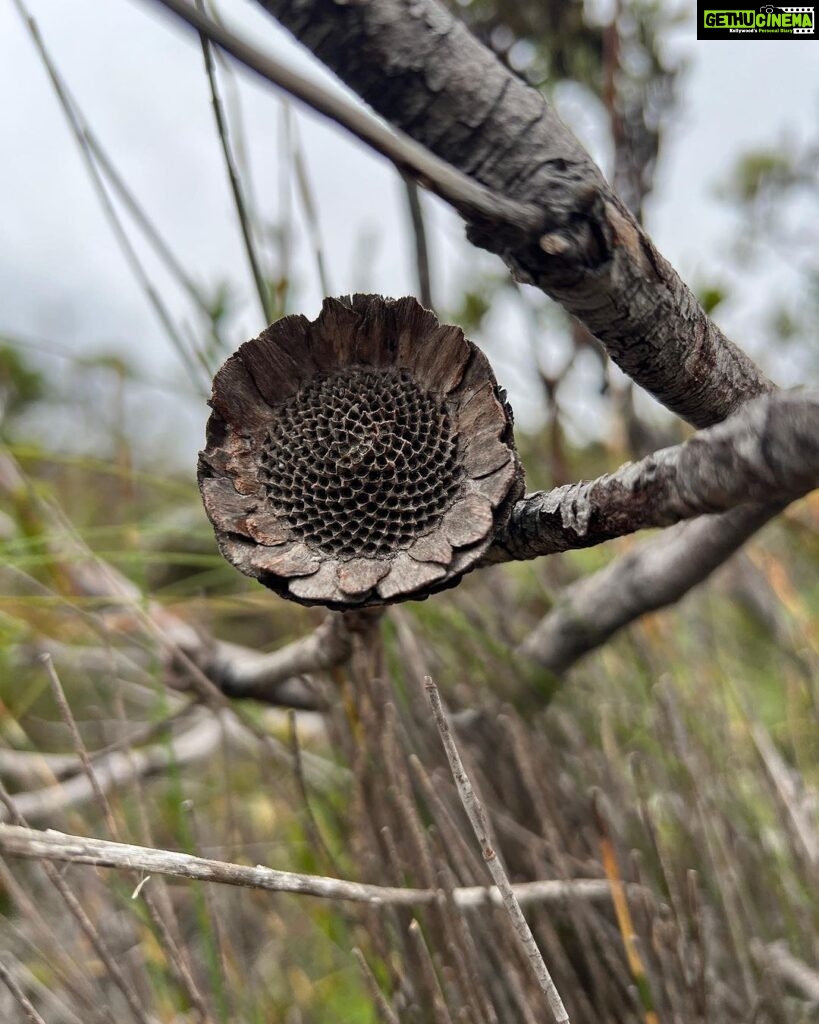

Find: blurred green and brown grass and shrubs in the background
<box><xmin>0</xmin><ymin>0</ymin><xmax>819</xmax><ymax>1024</ymax></box>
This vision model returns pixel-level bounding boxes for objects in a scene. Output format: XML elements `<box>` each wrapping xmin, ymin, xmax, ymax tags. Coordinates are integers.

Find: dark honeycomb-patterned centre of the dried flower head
<box><xmin>260</xmin><ymin>367</ymin><xmax>463</xmax><ymax>558</ymax></box>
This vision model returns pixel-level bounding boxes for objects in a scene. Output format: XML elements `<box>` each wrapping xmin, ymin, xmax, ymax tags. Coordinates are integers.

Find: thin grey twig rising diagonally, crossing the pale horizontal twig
<box><xmin>424</xmin><ymin>676</ymin><xmax>569</xmax><ymax>1024</ymax></box>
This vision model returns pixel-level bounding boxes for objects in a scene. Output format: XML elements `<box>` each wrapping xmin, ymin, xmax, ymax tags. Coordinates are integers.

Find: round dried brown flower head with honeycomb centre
<box><xmin>199</xmin><ymin>295</ymin><xmax>522</xmax><ymax>607</ymax></box>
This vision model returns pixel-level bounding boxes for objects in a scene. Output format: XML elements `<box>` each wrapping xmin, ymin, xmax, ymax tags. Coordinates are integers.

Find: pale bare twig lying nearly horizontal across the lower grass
<box><xmin>0</xmin><ymin>823</ymin><xmax>639</xmax><ymax>913</ymax></box>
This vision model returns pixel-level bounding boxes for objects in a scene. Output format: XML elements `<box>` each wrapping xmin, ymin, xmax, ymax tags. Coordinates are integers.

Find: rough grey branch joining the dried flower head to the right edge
<box><xmin>486</xmin><ymin>392</ymin><xmax>819</xmax><ymax>562</ymax></box>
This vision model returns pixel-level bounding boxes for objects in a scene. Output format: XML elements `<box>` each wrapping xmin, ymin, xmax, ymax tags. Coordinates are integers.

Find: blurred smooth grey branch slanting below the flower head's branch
<box><xmin>520</xmin><ymin>504</ymin><xmax>783</xmax><ymax>675</ymax></box>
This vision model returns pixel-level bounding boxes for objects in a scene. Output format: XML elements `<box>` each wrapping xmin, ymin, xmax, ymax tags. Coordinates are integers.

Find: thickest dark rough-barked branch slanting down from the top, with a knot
<box><xmin>259</xmin><ymin>0</ymin><xmax>772</xmax><ymax>427</ymax></box>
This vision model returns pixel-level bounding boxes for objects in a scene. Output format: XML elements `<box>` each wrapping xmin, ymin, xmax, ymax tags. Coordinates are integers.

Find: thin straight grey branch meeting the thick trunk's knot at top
<box><xmin>144</xmin><ymin>0</ymin><xmax>544</xmax><ymax>233</ymax></box>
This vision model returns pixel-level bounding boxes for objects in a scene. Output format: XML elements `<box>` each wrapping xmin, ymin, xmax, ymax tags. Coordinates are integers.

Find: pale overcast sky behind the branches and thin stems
<box><xmin>0</xmin><ymin>0</ymin><xmax>819</xmax><ymax>464</ymax></box>
